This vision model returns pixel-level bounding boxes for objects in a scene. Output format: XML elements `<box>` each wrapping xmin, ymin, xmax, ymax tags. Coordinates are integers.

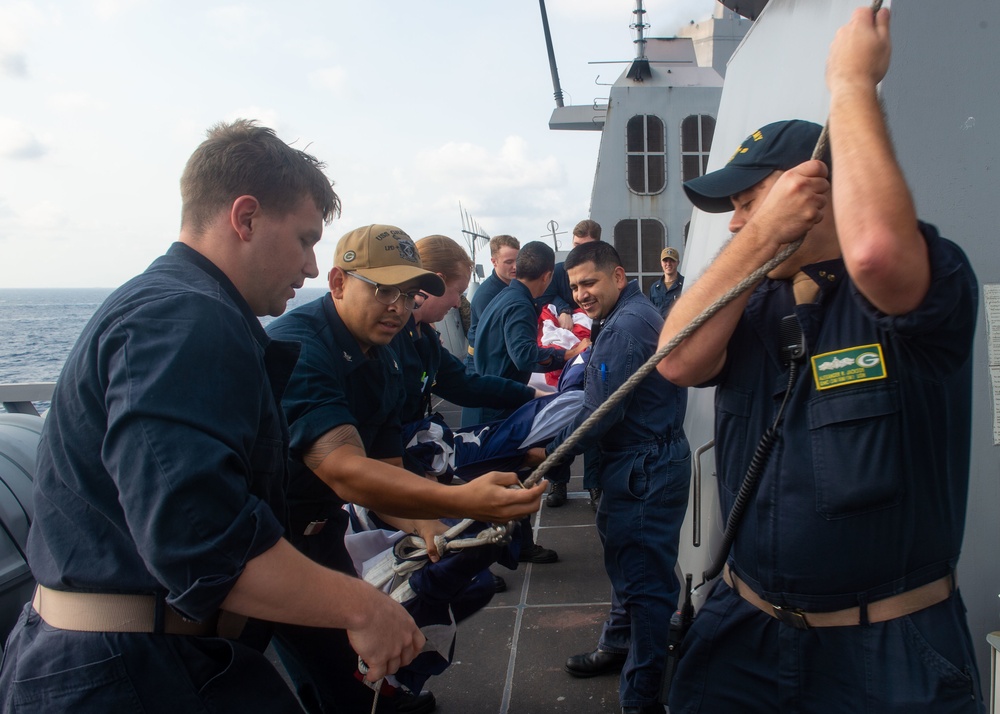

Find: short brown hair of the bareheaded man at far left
<box><xmin>181</xmin><ymin>119</ymin><xmax>340</xmax><ymax>234</ymax></box>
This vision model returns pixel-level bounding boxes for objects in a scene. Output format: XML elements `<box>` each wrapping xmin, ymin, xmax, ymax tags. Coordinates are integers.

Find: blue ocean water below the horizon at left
<box><xmin>0</xmin><ymin>287</ymin><xmax>326</xmax><ymax>384</ymax></box>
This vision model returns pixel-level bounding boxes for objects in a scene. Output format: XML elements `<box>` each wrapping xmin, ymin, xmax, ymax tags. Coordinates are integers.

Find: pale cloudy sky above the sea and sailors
<box><xmin>0</xmin><ymin>0</ymin><xmax>715</xmax><ymax>288</ymax></box>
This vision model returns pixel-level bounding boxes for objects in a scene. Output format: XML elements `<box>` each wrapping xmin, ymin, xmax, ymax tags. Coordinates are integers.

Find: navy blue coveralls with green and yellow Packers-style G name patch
<box><xmin>670</xmin><ymin>224</ymin><xmax>982</xmax><ymax>714</ymax></box>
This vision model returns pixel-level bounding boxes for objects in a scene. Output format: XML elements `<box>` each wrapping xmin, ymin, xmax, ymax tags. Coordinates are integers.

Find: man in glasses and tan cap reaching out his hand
<box><xmin>267</xmin><ymin>225</ymin><xmax>545</xmax><ymax>711</ymax></box>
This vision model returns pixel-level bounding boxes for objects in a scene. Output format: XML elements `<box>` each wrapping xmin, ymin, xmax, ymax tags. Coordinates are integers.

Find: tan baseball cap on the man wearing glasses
<box><xmin>333</xmin><ymin>224</ymin><xmax>444</xmax><ymax>296</ymax></box>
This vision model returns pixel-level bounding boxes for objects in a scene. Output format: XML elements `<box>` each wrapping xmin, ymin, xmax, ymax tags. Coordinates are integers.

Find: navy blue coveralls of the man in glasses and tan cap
<box><xmin>267</xmin><ymin>293</ymin><xmax>403</xmax><ymax>712</ymax></box>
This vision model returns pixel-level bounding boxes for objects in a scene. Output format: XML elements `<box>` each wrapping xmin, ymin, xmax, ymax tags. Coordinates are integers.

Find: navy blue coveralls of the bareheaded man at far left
<box><xmin>0</xmin><ymin>243</ymin><xmax>301</xmax><ymax>714</ymax></box>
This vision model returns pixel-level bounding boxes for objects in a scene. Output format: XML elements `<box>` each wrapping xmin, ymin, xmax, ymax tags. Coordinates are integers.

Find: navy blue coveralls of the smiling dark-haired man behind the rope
<box><xmin>546</xmin><ymin>280</ymin><xmax>691</xmax><ymax>707</ymax></box>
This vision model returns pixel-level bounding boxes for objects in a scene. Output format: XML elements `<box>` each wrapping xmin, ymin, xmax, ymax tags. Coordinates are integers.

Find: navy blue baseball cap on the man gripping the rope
<box><xmin>684</xmin><ymin>119</ymin><xmax>823</xmax><ymax>213</ymax></box>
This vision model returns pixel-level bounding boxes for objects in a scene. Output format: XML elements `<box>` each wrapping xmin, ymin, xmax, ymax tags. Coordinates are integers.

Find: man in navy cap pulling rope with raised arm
<box><xmin>659</xmin><ymin>9</ymin><xmax>983</xmax><ymax>714</ymax></box>
